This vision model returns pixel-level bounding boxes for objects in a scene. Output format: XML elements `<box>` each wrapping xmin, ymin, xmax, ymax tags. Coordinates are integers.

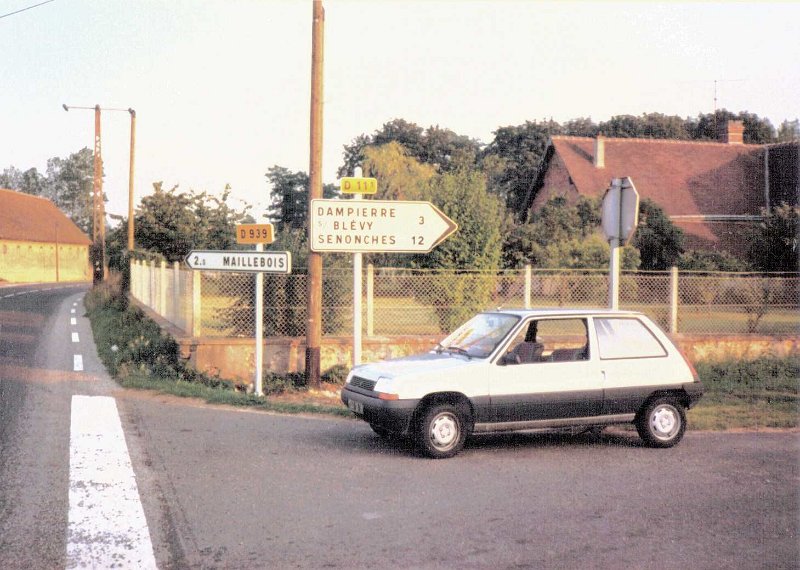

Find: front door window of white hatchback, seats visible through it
<box><xmin>503</xmin><ymin>319</ymin><xmax>589</xmax><ymax>364</ymax></box>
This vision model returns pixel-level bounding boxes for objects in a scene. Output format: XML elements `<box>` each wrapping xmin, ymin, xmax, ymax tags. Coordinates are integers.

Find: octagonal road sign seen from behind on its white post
<box><xmin>602</xmin><ymin>177</ymin><xmax>639</xmax><ymax>309</ymax></box>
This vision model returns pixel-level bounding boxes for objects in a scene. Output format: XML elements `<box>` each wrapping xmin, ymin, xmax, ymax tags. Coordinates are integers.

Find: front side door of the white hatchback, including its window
<box><xmin>489</xmin><ymin>317</ymin><xmax>603</xmax><ymax>422</ymax></box>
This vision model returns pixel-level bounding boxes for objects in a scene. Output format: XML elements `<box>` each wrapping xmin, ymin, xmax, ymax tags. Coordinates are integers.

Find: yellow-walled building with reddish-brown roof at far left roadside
<box><xmin>0</xmin><ymin>189</ymin><xmax>92</xmax><ymax>283</ymax></box>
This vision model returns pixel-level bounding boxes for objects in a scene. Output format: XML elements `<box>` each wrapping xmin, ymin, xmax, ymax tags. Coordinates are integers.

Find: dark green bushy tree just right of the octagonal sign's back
<box><xmin>633</xmin><ymin>198</ymin><xmax>684</xmax><ymax>271</ymax></box>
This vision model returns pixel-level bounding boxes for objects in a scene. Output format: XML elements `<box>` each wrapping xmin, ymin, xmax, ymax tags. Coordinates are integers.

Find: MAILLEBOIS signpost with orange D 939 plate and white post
<box><xmin>186</xmin><ymin>246</ymin><xmax>292</xmax><ymax>396</ymax></box>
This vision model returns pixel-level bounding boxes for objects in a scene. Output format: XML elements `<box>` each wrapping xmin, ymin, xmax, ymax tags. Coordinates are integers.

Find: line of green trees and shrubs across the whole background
<box><xmin>0</xmin><ymin>110</ymin><xmax>800</xmax><ymax>272</ymax></box>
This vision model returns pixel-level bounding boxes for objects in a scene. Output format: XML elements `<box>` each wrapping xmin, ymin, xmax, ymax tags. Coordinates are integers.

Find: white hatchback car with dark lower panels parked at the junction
<box><xmin>342</xmin><ymin>309</ymin><xmax>703</xmax><ymax>458</ymax></box>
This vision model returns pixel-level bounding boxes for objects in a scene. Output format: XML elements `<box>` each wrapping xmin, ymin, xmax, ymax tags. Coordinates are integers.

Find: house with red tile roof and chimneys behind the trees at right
<box><xmin>527</xmin><ymin>121</ymin><xmax>800</xmax><ymax>255</ymax></box>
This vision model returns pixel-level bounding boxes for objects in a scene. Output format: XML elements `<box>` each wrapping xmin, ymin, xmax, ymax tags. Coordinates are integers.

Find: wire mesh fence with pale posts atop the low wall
<box><xmin>131</xmin><ymin>262</ymin><xmax>800</xmax><ymax>337</ymax></box>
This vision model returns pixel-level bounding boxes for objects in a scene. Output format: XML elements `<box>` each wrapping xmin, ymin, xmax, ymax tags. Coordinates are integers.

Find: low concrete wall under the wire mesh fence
<box><xmin>133</xmin><ymin>301</ymin><xmax>800</xmax><ymax>384</ymax></box>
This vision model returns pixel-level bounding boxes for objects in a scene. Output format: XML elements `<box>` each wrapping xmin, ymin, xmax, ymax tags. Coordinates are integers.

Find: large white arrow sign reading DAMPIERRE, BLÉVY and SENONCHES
<box><xmin>311</xmin><ymin>200</ymin><xmax>458</xmax><ymax>253</ymax></box>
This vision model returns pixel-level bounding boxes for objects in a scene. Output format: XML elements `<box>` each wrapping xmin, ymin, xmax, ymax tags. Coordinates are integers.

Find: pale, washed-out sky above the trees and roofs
<box><xmin>0</xmin><ymin>0</ymin><xmax>800</xmax><ymax>217</ymax></box>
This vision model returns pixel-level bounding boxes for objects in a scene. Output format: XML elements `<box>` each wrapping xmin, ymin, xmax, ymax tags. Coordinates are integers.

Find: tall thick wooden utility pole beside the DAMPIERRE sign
<box><xmin>306</xmin><ymin>0</ymin><xmax>325</xmax><ymax>388</ymax></box>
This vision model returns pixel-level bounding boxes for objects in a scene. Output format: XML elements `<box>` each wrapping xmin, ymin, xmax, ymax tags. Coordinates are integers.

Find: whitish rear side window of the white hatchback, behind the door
<box><xmin>594</xmin><ymin>317</ymin><xmax>667</xmax><ymax>360</ymax></box>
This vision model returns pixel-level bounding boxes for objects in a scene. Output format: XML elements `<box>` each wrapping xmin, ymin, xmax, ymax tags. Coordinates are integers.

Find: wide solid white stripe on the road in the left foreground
<box><xmin>66</xmin><ymin>395</ymin><xmax>157</xmax><ymax>569</ymax></box>
